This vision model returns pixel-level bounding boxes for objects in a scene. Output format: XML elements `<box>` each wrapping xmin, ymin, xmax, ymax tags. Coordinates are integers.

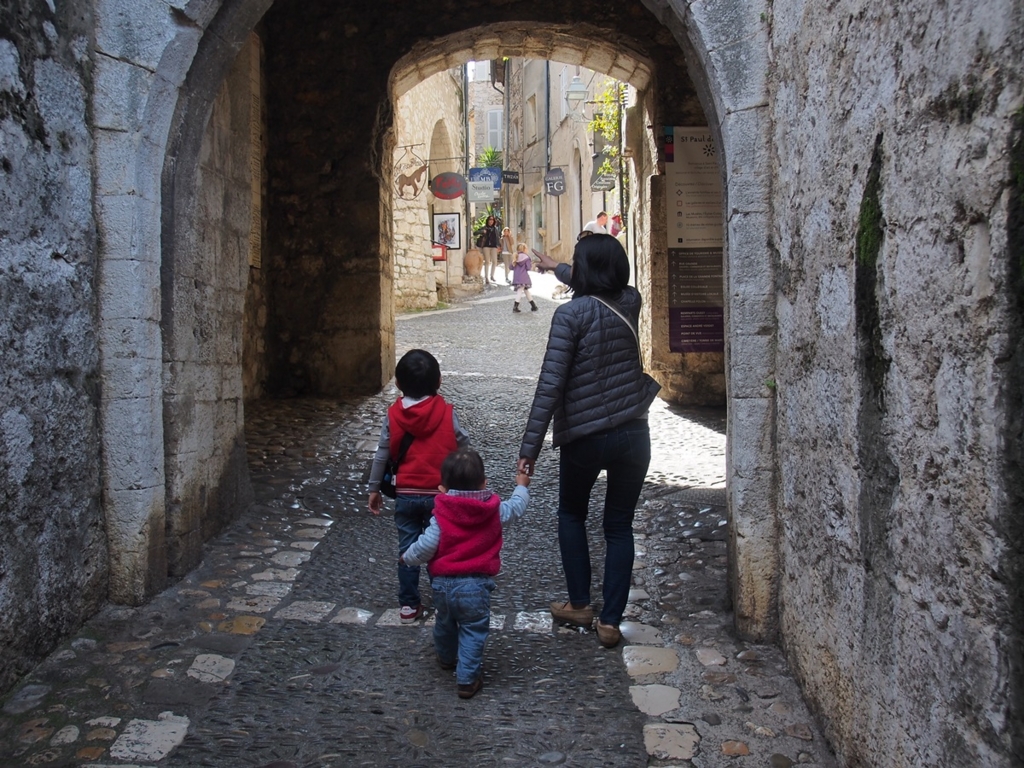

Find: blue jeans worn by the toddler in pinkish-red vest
<box><xmin>430</xmin><ymin>575</ymin><xmax>495</xmax><ymax>685</ymax></box>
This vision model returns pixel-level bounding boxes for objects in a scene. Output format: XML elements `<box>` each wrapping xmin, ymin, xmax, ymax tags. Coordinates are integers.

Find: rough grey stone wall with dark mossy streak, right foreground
<box><xmin>766</xmin><ymin>0</ymin><xmax>1024</xmax><ymax>766</ymax></box>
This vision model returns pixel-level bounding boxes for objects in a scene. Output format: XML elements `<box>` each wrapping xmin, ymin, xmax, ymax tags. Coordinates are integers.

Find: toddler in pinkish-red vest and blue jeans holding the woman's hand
<box><xmin>401</xmin><ymin>449</ymin><xmax>529</xmax><ymax>698</ymax></box>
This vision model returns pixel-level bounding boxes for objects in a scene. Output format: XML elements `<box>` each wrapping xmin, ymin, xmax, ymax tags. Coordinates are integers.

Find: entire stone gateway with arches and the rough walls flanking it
<box><xmin>0</xmin><ymin>0</ymin><xmax>1024</xmax><ymax>766</ymax></box>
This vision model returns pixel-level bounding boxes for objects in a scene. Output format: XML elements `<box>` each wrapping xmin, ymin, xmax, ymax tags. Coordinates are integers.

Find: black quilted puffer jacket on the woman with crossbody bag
<box><xmin>519</xmin><ymin>264</ymin><xmax>662</xmax><ymax>460</ymax></box>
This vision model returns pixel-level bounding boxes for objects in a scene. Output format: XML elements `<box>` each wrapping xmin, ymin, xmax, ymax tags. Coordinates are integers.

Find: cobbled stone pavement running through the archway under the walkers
<box><xmin>0</xmin><ymin>279</ymin><xmax>835</xmax><ymax>768</ymax></box>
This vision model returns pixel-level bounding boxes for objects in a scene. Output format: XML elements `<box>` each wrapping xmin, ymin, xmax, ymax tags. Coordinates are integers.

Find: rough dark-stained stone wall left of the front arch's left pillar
<box><xmin>0</xmin><ymin>0</ymin><xmax>108</xmax><ymax>691</ymax></box>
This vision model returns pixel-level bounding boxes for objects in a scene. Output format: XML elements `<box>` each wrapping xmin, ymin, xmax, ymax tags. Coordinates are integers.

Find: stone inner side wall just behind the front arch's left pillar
<box><xmin>164</xmin><ymin>37</ymin><xmax>256</xmax><ymax>575</ymax></box>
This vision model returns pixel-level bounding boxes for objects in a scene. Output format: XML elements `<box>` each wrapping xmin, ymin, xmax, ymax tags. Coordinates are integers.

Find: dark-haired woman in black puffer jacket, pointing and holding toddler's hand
<box><xmin>519</xmin><ymin>234</ymin><xmax>660</xmax><ymax>648</ymax></box>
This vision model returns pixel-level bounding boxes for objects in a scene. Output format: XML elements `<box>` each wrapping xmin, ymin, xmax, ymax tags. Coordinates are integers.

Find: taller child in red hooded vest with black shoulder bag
<box><xmin>369</xmin><ymin>349</ymin><xmax>469</xmax><ymax>624</ymax></box>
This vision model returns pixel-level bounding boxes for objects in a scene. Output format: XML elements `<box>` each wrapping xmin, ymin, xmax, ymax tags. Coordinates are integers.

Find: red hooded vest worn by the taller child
<box><xmin>387</xmin><ymin>394</ymin><xmax>459</xmax><ymax>496</ymax></box>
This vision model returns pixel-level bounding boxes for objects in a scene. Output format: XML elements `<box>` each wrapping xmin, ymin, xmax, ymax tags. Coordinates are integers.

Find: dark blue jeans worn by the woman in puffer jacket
<box><xmin>558</xmin><ymin>419</ymin><xmax>650</xmax><ymax>627</ymax></box>
